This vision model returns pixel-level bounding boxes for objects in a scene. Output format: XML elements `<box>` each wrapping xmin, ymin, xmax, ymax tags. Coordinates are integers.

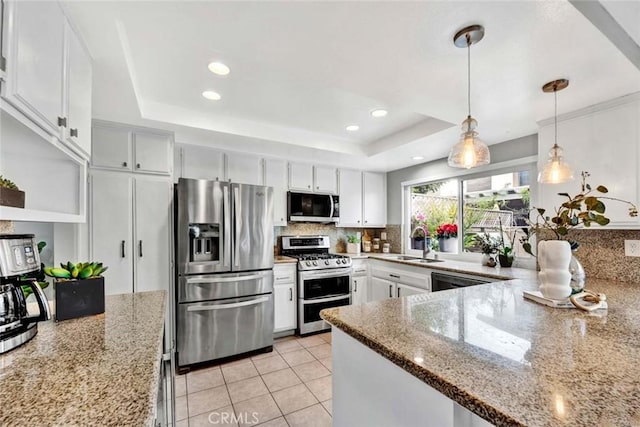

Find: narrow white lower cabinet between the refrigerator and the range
<box><xmin>273</xmin><ymin>263</ymin><xmax>298</xmax><ymax>332</ymax></box>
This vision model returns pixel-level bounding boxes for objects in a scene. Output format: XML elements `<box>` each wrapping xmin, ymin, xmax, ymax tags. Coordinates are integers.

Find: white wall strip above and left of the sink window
<box><xmin>387</xmin><ymin>134</ymin><xmax>538</xmax><ymax>224</ymax></box>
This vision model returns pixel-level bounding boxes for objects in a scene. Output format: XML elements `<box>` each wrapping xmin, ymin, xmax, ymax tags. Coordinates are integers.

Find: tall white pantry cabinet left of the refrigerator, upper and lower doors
<box><xmin>89</xmin><ymin>121</ymin><xmax>173</xmax><ymax>294</ymax></box>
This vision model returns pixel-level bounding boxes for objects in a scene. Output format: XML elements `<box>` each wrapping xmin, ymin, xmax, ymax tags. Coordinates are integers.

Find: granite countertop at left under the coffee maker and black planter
<box><xmin>0</xmin><ymin>291</ymin><xmax>166</xmax><ymax>426</ymax></box>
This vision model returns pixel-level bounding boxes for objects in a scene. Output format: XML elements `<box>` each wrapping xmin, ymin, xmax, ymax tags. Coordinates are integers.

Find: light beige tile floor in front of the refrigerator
<box><xmin>176</xmin><ymin>332</ymin><xmax>331</xmax><ymax>427</ymax></box>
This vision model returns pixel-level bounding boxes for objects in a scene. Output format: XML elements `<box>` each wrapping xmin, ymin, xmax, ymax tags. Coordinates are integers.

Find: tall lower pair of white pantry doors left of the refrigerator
<box><xmin>89</xmin><ymin>170</ymin><xmax>172</xmax><ymax>295</ymax></box>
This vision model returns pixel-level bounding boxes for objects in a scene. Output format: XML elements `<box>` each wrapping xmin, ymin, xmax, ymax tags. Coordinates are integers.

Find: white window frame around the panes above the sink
<box><xmin>401</xmin><ymin>156</ymin><xmax>538</xmax><ymax>267</ymax></box>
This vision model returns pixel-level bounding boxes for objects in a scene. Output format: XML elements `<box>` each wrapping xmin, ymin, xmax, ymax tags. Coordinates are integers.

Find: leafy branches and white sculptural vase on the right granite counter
<box><xmin>521</xmin><ymin>171</ymin><xmax>638</xmax><ymax>299</ymax></box>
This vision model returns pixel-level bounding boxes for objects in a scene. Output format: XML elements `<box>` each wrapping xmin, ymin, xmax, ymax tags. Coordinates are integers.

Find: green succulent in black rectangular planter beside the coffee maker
<box><xmin>44</xmin><ymin>261</ymin><xmax>108</xmax><ymax>321</ymax></box>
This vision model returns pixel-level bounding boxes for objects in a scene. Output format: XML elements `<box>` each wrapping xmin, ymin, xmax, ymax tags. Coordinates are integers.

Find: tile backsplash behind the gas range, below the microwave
<box><xmin>274</xmin><ymin>223</ymin><xmax>392</xmax><ymax>253</ymax></box>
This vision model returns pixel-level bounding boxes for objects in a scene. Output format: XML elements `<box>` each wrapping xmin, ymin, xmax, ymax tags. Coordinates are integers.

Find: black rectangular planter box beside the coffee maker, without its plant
<box><xmin>55</xmin><ymin>277</ymin><xmax>104</xmax><ymax>321</ymax></box>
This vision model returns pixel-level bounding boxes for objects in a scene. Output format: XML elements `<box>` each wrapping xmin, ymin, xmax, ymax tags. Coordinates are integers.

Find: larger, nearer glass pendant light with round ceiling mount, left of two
<box><xmin>449</xmin><ymin>25</ymin><xmax>491</xmax><ymax>169</ymax></box>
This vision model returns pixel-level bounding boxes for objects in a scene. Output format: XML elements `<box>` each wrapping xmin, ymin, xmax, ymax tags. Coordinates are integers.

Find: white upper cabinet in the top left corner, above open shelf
<box><xmin>2</xmin><ymin>1</ymin><xmax>92</xmax><ymax>159</ymax></box>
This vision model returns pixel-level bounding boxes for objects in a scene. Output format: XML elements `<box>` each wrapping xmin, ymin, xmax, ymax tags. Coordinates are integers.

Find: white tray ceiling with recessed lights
<box><xmin>65</xmin><ymin>1</ymin><xmax>640</xmax><ymax>170</ymax></box>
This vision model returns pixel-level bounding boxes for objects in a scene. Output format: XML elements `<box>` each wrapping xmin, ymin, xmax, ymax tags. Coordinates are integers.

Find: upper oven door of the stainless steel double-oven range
<box><xmin>298</xmin><ymin>268</ymin><xmax>351</xmax><ymax>300</ymax></box>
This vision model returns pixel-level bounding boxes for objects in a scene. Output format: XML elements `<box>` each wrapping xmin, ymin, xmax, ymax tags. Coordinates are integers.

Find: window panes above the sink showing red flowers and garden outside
<box><xmin>405</xmin><ymin>167</ymin><xmax>533</xmax><ymax>257</ymax></box>
